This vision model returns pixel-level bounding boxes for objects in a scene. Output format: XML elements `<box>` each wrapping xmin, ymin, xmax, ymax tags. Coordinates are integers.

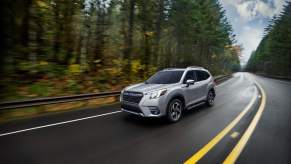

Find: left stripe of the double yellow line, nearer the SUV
<box><xmin>184</xmin><ymin>85</ymin><xmax>257</xmax><ymax>164</ymax></box>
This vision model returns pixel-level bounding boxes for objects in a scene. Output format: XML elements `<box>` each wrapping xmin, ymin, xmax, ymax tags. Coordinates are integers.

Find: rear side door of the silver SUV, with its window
<box><xmin>195</xmin><ymin>70</ymin><xmax>210</xmax><ymax>101</ymax></box>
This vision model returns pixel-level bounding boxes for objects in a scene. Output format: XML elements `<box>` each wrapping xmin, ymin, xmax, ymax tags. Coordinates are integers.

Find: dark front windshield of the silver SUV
<box><xmin>145</xmin><ymin>70</ymin><xmax>184</xmax><ymax>84</ymax></box>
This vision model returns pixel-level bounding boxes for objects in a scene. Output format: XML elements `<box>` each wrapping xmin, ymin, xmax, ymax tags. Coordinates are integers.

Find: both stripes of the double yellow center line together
<box><xmin>184</xmin><ymin>82</ymin><xmax>266</xmax><ymax>164</ymax></box>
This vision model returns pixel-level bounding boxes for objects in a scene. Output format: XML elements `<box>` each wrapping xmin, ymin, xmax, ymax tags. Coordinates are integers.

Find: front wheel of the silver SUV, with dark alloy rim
<box><xmin>167</xmin><ymin>99</ymin><xmax>184</xmax><ymax>123</ymax></box>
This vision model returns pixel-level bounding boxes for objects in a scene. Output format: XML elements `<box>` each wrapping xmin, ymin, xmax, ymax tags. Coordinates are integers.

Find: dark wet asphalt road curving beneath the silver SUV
<box><xmin>0</xmin><ymin>73</ymin><xmax>291</xmax><ymax>164</ymax></box>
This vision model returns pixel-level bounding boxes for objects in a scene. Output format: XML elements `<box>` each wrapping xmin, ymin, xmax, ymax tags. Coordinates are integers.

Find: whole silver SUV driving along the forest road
<box><xmin>120</xmin><ymin>66</ymin><xmax>215</xmax><ymax>122</ymax></box>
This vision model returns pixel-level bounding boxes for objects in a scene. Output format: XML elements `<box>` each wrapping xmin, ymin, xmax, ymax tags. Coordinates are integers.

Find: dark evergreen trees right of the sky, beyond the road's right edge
<box><xmin>246</xmin><ymin>2</ymin><xmax>291</xmax><ymax>77</ymax></box>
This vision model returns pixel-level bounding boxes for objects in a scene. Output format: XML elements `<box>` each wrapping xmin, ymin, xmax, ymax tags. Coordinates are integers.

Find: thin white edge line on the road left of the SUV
<box><xmin>0</xmin><ymin>111</ymin><xmax>122</xmax><ymax>137</ymax></box>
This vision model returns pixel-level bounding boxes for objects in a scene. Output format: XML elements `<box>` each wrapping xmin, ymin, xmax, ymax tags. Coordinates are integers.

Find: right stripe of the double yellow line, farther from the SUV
<box><xmin>223</xmin><ymin>82</ymin><xmax>267</xmax><ymax>164</ymax></box>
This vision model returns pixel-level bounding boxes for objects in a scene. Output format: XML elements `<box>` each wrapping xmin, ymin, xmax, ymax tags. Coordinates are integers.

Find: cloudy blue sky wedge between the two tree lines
<box><xmin>219</xmin><ymin>0</ymin><xmax>291</xmax><ymax>65</ymax></box>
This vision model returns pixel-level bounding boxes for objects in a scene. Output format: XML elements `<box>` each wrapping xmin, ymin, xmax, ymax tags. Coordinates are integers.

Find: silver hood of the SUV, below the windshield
<box><xmin>125</xmin><ymin>83</ymin><xmax>177</xmax><ymax>93</ymax></box>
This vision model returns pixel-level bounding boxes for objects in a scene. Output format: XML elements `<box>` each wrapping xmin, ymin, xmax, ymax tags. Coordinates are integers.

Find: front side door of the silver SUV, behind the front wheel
<box><xmin>183</xmin><ymin>70</ymin><xmax>198</xmax><ymax>107</ymax></box>
